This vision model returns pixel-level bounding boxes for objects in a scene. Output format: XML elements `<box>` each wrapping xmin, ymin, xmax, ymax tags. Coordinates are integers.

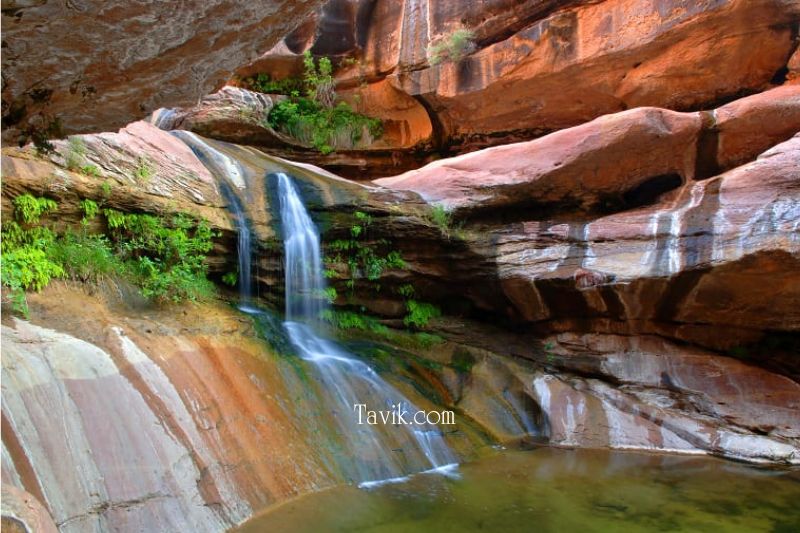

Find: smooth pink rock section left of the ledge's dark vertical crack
<box><xmin>375</xmin><ymin>108</ymin><xmax>700</xmax><ymax>211</ymax></box>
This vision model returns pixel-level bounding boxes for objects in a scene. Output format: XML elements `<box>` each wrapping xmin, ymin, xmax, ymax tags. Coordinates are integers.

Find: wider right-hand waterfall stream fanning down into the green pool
<box><xmin>277</xmin><ymin>172</ymin><xmax>456</xmax><ymax>487</ymax></box>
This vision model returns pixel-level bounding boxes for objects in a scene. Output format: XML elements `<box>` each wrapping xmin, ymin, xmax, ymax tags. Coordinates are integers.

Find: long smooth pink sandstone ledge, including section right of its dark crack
<box><xmin>375</xmin><ymin>85</ymin><xmax>800</xmax><ymax>217</ymax></box>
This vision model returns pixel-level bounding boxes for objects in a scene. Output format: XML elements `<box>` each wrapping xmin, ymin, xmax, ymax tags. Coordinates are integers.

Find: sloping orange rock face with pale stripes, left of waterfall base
<box><xmin>2</xmin><ymin>282</ymin><xmax>482</xmax><ymax>532</ymax></box>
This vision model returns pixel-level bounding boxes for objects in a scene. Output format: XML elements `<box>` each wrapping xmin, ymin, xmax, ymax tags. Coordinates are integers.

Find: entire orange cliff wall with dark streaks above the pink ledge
<box><xmin>247</xmin><ymin>0</ymin><xmax>800</xmax><ymax>151</ymax></box>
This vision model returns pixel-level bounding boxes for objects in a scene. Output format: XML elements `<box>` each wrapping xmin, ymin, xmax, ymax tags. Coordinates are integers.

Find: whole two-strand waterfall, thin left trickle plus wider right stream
<box><xmin>171</xmin><ymin>127</ymin><xmax>457</xmax><ymax>486</ymax></box>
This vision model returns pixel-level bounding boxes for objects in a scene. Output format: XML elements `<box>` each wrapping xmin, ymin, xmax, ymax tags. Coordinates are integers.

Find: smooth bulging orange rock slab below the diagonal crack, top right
<box><xmin>376</xmin><ymin>0</ymin><xmax>798</xmax><ymax>145</ymax></box>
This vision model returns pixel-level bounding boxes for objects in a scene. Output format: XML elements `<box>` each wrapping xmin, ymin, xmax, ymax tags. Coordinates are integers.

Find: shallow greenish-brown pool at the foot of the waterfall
<box><xmin>237</xmin><ymin>448</ymin><xmax>800</xmax><ymax>533</ymax></box>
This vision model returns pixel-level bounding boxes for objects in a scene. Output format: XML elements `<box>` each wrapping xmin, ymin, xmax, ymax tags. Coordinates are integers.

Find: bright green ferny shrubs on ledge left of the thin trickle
<box><xmin>2</xmin><ymin>194</ymin><xmax>219</xmax><ymax>316</ymax></box>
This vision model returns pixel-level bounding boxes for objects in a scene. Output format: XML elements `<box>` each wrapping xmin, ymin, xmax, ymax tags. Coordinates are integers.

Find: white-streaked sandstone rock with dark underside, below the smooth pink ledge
<box><xmin>494</xmin><ymin>136</ymin><xmax>800</xmax><ymax>348</ymax></box>
